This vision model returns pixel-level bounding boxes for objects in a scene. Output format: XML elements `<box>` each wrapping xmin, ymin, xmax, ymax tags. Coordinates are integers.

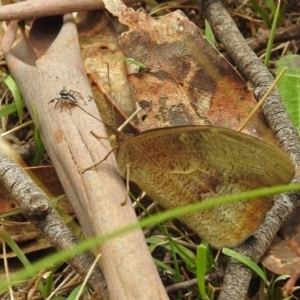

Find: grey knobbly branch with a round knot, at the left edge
<box><xmin>0</xmin><ymin>154</ymin><xmax>107</xmax><ymax>299</ymax></box>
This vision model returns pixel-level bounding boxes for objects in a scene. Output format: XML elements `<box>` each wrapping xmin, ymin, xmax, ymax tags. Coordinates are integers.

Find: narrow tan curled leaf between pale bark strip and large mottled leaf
<box><xmin>78</xmin><ymin>11</ymin><xmax>135</xmax><ymax>127</ymax></box>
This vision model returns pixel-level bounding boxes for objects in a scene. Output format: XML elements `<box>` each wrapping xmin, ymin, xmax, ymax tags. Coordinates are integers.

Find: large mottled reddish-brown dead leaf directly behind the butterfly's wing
<box><xmin>119</xmin><ymin>8</ymin><xmax>274</xmax><ymax>142</ymax></box>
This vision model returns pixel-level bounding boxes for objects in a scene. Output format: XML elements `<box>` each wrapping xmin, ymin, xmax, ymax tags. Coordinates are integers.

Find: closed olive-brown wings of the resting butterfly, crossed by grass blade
<box><xmin>116</xmin><ymin>126</ymin><xmax>294</xmax><ymax>248</ymax></box>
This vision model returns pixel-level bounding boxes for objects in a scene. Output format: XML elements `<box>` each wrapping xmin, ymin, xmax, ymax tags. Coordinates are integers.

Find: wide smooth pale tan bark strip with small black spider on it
<box><xmin>3</xmin><ymin>15</ymin><xmax>167</xmax><ymax>299</ymax></box>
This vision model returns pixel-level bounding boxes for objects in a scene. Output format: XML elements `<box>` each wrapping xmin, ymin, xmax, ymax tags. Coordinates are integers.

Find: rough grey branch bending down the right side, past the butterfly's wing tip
<box><xmin>203</xmin><ymin>0</ymin><xmax>300</xmax><ymax>299</ymax></box>
